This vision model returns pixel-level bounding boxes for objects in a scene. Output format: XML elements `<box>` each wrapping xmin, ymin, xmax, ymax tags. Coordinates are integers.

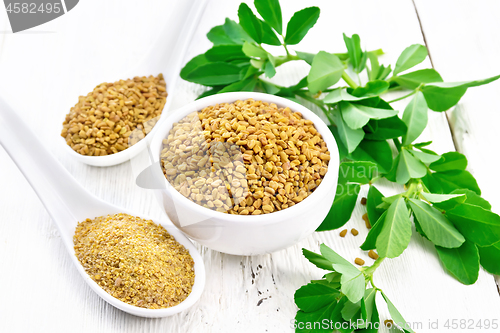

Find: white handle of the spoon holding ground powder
<box><xmin>0</xmin><ymin>97</ymin><xmax>95</xmax><ymax>245</ymax></box>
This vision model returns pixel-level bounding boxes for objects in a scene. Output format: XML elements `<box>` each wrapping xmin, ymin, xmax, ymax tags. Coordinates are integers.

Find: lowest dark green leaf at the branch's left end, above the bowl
<box><xmin>186</xmin><ymin>62</ymin><xmax>240</xmax><ymax>86</ymax></box>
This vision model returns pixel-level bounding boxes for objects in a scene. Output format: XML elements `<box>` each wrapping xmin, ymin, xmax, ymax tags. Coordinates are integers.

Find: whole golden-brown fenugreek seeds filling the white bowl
<box><xmin>161</xmin><ymin>99</ymin><xmax>330</xmax><ymax>215</ymax></box>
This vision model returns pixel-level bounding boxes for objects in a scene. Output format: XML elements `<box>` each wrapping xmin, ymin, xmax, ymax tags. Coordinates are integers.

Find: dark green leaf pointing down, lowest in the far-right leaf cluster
<box><xmin>436</xmin><ymin>240</ymin><xmax>479</xmax><ymax>285</ymax></box>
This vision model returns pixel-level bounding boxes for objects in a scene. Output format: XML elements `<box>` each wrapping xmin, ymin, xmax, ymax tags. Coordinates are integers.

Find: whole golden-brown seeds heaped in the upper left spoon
<box><xmin>61</xmin><ymin>74</ymin><xmax>167</xmax><ymax>156</ymax></box>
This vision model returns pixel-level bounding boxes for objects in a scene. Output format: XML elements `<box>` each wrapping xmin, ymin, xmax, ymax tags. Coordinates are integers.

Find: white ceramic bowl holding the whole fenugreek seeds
<box><xmin>151</xmin><ymin>92</ymin><xmax>339</xmax><ymax>255</ymax></box>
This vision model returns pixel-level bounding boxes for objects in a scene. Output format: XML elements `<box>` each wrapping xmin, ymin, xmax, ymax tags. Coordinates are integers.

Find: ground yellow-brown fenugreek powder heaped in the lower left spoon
<box><xmin>73</xmin><ymin>214</ymin><xmax>194</xmax><ymax>309</ymax></box>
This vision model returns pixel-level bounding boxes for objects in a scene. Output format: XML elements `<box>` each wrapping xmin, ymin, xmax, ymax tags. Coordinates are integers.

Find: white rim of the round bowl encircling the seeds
<box><xmin>150</xmin><ymin>92</ymin><xmax>340</xmax><ymax>225</ymax></box>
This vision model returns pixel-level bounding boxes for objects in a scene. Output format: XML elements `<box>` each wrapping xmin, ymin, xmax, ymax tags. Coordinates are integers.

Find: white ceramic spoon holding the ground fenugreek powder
<box><xmin>0</xmin><ymin>97</ymin><xmax>205</xmax><ymax>318</ymax></box>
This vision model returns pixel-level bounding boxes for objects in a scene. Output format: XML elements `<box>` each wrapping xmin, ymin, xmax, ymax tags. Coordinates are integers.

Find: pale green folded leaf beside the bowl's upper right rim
<box><xmin>340</xmin><ymin>101</ymin><xmax>398</xmax><ymax>129</ymax></box>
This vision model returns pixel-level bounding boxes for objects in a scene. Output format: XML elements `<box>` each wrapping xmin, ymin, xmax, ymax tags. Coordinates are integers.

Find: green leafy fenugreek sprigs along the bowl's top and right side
<box><xmin>180</xmin><ymin>0</ymin><xmax>500</xmax><ymax>332</ymax></box>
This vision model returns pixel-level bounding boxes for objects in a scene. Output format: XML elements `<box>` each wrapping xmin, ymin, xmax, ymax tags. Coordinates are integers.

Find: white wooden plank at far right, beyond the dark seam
<box><xmin>415</xmin><ymin>0</ymin><xmax>500</xmax><ymax>285</ymax></box>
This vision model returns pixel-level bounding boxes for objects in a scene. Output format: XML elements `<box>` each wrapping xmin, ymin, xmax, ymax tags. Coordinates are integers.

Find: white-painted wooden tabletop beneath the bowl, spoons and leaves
<box><xmin>0</xmin><ymin>0</ymin><xmax>500</xmax><ymax>333</ymax></box>
